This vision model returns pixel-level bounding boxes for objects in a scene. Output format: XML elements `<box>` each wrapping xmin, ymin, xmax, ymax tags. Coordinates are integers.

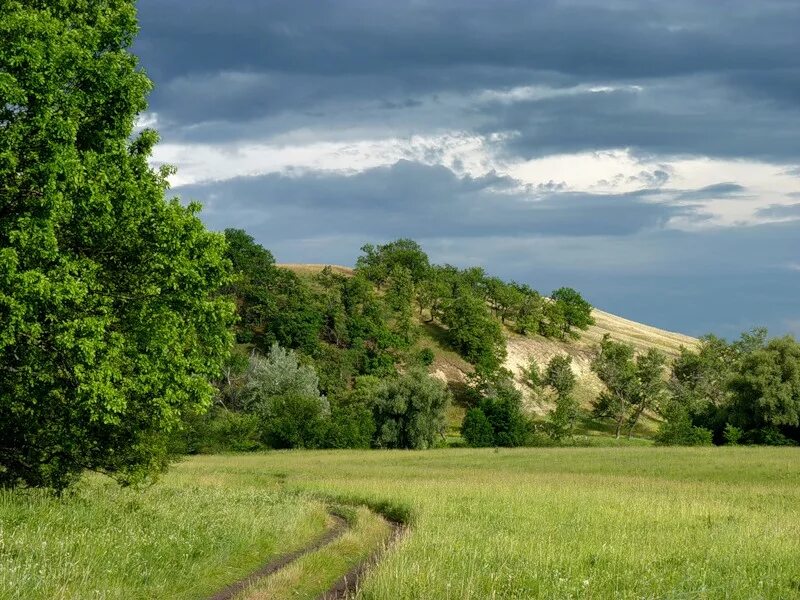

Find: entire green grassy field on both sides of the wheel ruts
<box><xmin>0</xmin><ymin>447</ymin><xmax>800</xmax><ymax>600</ymax></box>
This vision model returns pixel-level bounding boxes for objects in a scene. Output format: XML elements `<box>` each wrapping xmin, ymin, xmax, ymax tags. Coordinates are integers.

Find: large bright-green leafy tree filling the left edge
<box><xmin>0</xmin><ymin>0</ymin><xmax>233</xmax><ymax>488</ymax></box>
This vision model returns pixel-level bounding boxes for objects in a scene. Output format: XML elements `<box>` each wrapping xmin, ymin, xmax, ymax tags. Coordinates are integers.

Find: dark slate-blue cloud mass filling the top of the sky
<box><xmin>136</xmin><ymin>0</ymin><xmax>800</xmax><ymax>160</ymax></box>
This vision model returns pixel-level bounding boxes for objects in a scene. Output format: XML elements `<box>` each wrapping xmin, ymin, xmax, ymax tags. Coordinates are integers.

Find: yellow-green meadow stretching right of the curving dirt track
<box><xmin>209</xmin><ymin>447</ymin><xmax>800</xmax><ymax>600</ymax></box>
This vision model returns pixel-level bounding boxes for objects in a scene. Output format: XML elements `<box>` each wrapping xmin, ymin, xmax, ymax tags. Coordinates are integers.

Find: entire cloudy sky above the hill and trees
<box><xmin>134</xmin><ymin>0</ymin><xmax>800</xmax><ymax>337</ymax></box>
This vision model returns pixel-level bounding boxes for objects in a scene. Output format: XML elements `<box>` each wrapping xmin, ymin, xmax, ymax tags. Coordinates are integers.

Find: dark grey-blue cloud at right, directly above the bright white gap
<box><xmin>481</xmin><ymin>83</ymin><xmax>800</xmax><ymax>162</ymax></box>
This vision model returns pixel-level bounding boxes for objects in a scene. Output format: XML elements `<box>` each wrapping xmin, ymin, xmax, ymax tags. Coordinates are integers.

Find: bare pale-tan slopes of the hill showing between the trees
<box><xmin>278</xmin><ymin>263</ymin><xmax>697</xmax><ymax>430</ymax></box>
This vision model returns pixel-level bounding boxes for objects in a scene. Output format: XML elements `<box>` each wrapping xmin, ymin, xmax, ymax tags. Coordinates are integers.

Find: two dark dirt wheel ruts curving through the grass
<box><xmin>209</xmin><ymin>513</ymin><xmax>405</xmax><ymax>600</ymax></box>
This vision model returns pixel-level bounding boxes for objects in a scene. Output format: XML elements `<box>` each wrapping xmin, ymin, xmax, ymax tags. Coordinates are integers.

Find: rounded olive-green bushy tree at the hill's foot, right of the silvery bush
<box><xmin>373</xmin><ymin>371</ymin><xmax>450</xmax><ymax>449</ymax></box>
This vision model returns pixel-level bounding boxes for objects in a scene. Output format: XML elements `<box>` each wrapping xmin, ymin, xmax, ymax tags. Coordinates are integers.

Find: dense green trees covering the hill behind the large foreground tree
<box><xmin>173</xmin><ymin>229</ymin><xmax>592</xmax><ymax>452</ymax></box>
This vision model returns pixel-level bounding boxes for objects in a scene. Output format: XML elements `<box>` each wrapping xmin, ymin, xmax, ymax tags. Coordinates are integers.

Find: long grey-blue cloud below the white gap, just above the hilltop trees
<box><xmin>177</xmin><ymin>161</ymin><xmax>695</xmax><ymax>240</ymax></box>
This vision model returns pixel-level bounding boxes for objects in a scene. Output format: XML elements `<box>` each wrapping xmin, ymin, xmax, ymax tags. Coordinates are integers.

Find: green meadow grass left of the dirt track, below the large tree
<box><xmin>0</xmin><ymin>467</ymin><xmax>328</xmax><ymax>600</ymax></box>
